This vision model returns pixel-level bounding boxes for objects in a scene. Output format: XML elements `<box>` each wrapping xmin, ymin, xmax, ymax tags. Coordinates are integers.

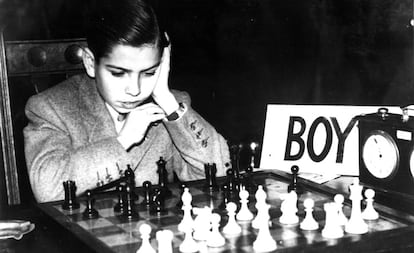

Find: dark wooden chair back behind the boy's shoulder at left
<box><xmin>0</xmin><ymin>33</ymin><xmax>86</xmax><ymax>209</ymax></box>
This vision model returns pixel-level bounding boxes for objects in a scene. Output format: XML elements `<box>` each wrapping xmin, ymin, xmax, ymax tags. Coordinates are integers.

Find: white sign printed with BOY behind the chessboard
<box><xmin>260</xmin><ymin>105</ymin><xmax>401</xmax><ymax>176</ymax></box>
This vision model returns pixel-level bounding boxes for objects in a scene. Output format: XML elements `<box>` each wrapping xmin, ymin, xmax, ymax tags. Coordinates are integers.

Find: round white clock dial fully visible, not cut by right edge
<box><xmin>362</xmin><ymin>130</ymin><xmax>398</xmax><ymax>179</ymax></box>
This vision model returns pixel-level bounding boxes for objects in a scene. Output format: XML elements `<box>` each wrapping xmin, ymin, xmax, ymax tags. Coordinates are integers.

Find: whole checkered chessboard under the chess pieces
<box><xmin>39</xmin><ymin>171</ymin><xmax>414</xmax><ymax>253</ymax></box>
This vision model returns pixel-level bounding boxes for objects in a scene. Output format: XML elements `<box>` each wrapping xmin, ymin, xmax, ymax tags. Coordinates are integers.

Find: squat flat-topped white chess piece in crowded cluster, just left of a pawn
<box><xmin>193</xmin><ymin>206</ymin><xmax>211</xmax><ymax>241</ymax></box>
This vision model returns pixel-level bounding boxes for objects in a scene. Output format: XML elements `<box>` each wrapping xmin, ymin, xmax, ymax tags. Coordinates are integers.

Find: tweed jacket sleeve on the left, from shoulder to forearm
<box><xmin>24</xmin><ymin>96</ymin><xmax>126</xmax><ymax>202</ymax></box>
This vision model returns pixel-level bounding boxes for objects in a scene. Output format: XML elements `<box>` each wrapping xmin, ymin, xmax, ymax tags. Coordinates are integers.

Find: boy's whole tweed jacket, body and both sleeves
<box><xmin>23</xmin><ymin>75</ymin><xmax>230</xmax><ymax>202</ymax></box>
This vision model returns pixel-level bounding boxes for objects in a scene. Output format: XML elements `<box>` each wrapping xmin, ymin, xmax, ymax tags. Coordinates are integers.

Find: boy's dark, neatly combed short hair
<box><xmin>85</xmin><ymin>0</ymin><xmax>167</xmax><ymax>61</ymax></box>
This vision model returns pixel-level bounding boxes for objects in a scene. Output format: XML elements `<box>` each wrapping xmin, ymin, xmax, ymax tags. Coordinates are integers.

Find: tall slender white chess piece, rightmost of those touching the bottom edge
<box><xmin>253</xmin><ymin>204</ymin><xmax>277</xmax><ymax>252</ymax></box>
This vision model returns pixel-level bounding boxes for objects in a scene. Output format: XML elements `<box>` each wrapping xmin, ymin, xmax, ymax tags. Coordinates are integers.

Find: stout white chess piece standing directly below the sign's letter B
<box><xmin>279</xmin><ymin>191</ymin><xmax>299</xmax><ymax>225</ymax></box>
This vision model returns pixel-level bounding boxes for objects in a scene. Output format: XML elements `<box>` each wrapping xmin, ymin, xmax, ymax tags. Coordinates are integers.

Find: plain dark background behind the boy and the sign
<box><xmin>0</xmin><ymin>0</ymin><xmax>414</xmax><ymax>141</ymax></box>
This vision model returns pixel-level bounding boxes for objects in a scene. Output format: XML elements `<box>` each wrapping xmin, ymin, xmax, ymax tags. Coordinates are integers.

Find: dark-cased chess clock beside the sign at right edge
<box><xmin>358</xmin><ymin>108</ymin><xmax>414</xmax><ymax>213</ymax></box>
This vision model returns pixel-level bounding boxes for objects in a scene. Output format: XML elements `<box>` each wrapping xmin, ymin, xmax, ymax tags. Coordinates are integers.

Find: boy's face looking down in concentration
<box><xmin>94</xmin><ymin>45</ymin><xmax>161</xmax><ymax>113</ymax></box>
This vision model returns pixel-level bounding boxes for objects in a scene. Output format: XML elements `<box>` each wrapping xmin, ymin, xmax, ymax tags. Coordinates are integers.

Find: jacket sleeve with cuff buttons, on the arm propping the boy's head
<box><xmin>164</xmin><ymin>91</ymin><xmax>231</xmax><ymax>181</ymax></box>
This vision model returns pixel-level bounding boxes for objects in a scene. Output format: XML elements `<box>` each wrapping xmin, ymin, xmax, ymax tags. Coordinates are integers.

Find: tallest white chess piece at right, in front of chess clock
<box><xmin>345</xmin><ymin>178</ymin><xmax>368</xmax><ymax>234</ymax></box>
